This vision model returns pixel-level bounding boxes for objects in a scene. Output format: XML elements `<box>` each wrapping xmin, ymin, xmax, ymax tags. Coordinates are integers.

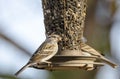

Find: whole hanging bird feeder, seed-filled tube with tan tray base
<box><xmin>31</xmin><ymin>0</ymin><xmax>104</xmax><ymax>70</ymax></box>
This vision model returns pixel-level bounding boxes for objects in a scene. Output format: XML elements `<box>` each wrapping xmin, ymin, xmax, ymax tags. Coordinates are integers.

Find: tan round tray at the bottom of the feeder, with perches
<box><xmin>31</xmin><ymin>51</ymin><xmax>104</xmax><ymax>70</ymax></box>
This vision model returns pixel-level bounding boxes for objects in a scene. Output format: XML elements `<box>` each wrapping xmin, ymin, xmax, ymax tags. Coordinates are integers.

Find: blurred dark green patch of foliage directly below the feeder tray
<box><xmin>48</xmin><ymin>70</ymin><xmax>96</xmax><ymax>79</ymax></box>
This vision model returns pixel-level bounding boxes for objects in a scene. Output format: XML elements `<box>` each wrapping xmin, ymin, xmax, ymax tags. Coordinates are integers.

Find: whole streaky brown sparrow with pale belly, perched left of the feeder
<box><xmin>15</xmin><ymin>35</ymin><xmax>61</xmax><ymax>76</ymax></box>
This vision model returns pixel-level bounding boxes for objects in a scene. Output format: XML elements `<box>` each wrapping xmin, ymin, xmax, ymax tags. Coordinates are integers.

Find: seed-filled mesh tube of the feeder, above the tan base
<box><xmin>42</xmin><ymin>0</ymin><xmax>87</xmax><ymax>50</ymax></box>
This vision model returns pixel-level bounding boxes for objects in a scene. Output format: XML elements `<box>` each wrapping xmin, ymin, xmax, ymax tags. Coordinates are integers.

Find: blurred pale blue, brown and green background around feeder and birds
<box><xmin>0</xmin><ymin>0</ymin><xmax>120</xmax><ymax>79</ymax></box>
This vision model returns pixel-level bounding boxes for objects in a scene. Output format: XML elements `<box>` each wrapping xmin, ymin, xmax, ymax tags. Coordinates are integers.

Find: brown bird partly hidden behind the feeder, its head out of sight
<box><xmin>81</xmin><ymin>43</ymin><xmax>117</xmax><ymax>68</ymax></box>
